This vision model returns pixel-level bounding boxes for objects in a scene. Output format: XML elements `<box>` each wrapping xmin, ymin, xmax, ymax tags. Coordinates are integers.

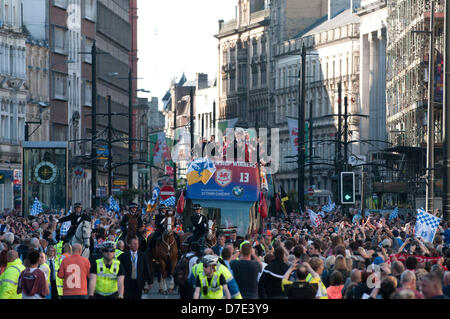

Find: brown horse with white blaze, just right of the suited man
<box><xmin>147</xmin><ymin>212</ymin><xmax>178</xmax><ymax>294</ymax></box>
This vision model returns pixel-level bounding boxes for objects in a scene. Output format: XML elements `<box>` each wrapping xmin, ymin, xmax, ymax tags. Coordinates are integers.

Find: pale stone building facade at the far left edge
<box><xmin>0</xmin><ymin>0</ymin><xmax>28</xmax><ymax>211</ymax></box>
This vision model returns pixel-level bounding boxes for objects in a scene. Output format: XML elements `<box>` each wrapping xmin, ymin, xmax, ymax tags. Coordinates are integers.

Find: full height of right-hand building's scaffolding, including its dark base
<box><xmin>386</xmin><ymin>0</ymin><xmax>445</xmax><ymax>204</ymax></box>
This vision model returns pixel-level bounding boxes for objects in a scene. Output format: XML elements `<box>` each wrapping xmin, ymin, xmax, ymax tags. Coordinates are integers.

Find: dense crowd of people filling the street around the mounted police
<box><xmin>0</xmin><ymin>202</ymin><xmax>450</xmax><ymax>299</ymax></box>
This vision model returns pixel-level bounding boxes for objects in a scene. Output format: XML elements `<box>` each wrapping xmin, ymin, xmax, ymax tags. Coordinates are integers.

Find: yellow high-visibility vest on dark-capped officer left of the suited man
<box><xmin>95</xmin><ymin>258</ymin><xmax>120</xmax><ymax>296</ymax></box>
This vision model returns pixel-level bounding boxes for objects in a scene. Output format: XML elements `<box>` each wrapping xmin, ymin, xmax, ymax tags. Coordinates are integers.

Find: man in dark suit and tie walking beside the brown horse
<box><xmin>119</xmin><ymin>238</ymin><xmax>153</xmax><ymax>299</ymax></box>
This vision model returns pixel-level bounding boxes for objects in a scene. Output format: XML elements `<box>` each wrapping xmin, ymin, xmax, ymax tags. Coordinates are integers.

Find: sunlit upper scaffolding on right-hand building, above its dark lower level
<box><xmin>386</xmin><ymin>0</ymin><xmax>445</xmax><ymax>148</ymax></box>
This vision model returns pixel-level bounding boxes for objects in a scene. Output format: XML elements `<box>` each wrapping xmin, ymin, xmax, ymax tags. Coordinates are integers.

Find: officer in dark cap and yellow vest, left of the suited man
<box><xmin>89</xmin><ymin>241</ymin><xmax>125</xmax><ymax>299</ymax></box>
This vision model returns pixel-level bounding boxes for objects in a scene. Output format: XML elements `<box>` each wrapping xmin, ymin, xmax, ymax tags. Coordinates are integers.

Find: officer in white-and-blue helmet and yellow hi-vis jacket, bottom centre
<box><xmin>194</xmin><ymin>255</ymin><xmax>231</xmax><ymax>299</ymax></box>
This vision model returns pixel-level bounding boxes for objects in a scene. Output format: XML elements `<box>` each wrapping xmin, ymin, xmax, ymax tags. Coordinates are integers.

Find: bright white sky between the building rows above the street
<box><xmin>137</xmin><ymin>0</ymin><xmax>236</xmax><ymax>107</ymax></box>
